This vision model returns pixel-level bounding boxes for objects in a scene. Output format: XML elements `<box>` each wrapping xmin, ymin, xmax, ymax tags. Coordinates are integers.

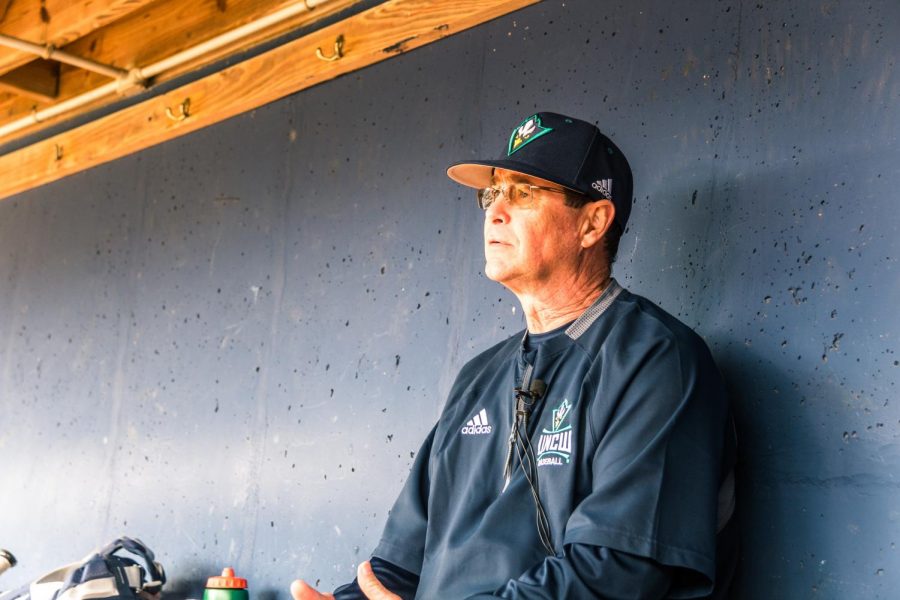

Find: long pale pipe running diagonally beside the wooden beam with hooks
<box><xmin>0</xmin><ymin>0</ymin><xmax>331</xmax><ymax>139</ymax></box>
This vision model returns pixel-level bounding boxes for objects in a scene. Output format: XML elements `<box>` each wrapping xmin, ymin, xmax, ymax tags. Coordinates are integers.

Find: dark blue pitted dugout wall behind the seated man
<box><xmin>0</xmin><ymin>0</ymin><xmax>900</xmax><ymax>599</ymax></box>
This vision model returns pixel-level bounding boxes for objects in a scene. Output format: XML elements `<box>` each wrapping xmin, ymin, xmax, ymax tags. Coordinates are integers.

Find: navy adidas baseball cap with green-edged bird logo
<box><xmin>447</xmin><ymin>112</ymin><xmax>634</xmax><ymax>231</ymax></box>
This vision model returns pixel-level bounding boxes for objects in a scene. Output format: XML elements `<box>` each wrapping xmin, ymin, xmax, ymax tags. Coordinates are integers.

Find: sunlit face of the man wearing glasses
<box><xmin>484</xmin><ymin>169</ymin><xmax>583</xmax><ymax>293</ymax></box>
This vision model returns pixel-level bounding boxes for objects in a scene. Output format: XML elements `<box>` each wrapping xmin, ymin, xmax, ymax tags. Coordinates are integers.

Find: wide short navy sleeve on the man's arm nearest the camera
<box><xmin>563</xmin><ymin>318</ymin><xmax>729</xmax><ymax>597</ymax></box>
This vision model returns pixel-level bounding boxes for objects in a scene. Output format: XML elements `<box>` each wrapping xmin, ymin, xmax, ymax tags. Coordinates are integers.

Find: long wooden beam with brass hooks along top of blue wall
<box><xmin>0</xmin><ymin>0</ymin><xmax>539</xmax><ymax>198</ymax></box>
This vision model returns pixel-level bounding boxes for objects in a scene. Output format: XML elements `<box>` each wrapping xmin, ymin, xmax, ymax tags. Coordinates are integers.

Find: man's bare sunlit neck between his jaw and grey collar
<box><xmin>516</xmin><ymin>274</ymin><xmax>611</xmax><ymax>333</ymax></box>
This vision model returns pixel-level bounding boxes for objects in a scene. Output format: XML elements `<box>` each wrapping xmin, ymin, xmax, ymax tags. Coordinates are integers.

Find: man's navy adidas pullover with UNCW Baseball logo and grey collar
<box><xmin>338</xmin><ymin>281</ymin><xmax>734</xmax><ymax>599</ymax></box>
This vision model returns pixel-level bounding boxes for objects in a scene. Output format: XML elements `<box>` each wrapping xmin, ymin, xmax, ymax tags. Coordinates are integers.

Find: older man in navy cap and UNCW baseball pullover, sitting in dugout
<box><xmin>292</xmin><ymin>113</ymin><xmax>736</xmax><ymax>600</ymax></box>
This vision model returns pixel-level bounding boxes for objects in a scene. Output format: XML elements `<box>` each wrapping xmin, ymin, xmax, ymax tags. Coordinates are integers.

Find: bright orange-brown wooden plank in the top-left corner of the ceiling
<box><xmin>0</xmin><ymin>0</ymin><xmax>155</xmax><ymax>74</ymax></box>
